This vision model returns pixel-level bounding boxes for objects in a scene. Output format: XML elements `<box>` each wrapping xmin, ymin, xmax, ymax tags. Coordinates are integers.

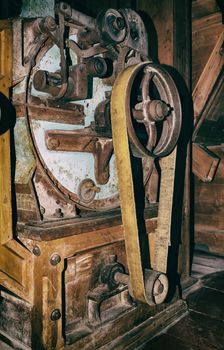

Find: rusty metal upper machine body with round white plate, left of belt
<box><xmin>15</xmin><ymin>4</ymin><xmax>147</xmax><ymax>219</ymax></box>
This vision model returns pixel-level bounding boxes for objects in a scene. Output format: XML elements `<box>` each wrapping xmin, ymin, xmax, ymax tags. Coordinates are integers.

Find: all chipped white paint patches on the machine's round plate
<box><xmin>31</xmin><ymin>39</ymin><xmax>118</xmax><ymax>206</ymax></box>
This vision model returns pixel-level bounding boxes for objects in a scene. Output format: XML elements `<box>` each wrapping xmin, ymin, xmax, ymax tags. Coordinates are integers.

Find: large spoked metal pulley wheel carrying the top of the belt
<box><xmin>126</xmin><ymin>62</ymin><xmax>182</xmax><ymax>158</ymax></box>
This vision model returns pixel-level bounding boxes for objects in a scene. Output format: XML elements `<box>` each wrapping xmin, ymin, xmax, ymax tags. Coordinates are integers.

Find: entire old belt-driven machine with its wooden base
<box><xmin>0</xmin><ymin>3</ymin><xmax>185</xmax><ymax>349</ymax></box>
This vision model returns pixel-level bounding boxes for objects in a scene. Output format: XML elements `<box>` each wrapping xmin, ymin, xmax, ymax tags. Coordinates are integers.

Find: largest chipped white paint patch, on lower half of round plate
<box><xmin>32</xmin><ymin>120</ymin><xmax>117</xmax><ymax>199</ymax></box>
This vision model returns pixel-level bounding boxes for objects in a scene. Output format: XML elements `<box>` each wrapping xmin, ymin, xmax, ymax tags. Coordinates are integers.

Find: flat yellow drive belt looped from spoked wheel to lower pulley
<box><xmin>111</xmin><ymin>62</ymin><xmax>176</xmax><ymax>305</ymax></box>
